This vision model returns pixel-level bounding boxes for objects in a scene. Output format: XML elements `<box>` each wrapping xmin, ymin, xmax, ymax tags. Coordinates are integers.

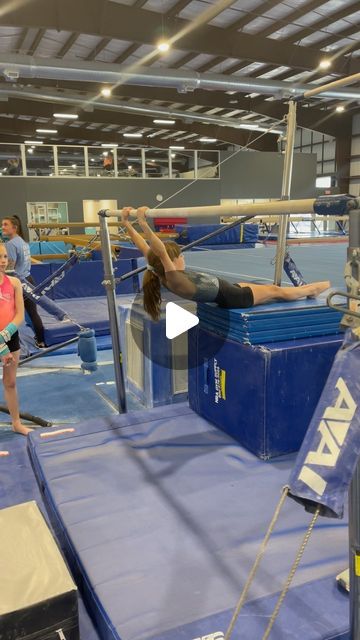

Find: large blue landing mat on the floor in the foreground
<box><xmin>28</xmin><ymin>404</ymin><xmax>348</xmax><ymax>640</ymax></box>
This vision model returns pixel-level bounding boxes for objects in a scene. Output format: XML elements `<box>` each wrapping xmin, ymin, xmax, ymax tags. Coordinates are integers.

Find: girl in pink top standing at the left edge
<box><xmin>0</xmin><ymin>243</ymin><xmax>32</xmax><ymax>436</ymax></box>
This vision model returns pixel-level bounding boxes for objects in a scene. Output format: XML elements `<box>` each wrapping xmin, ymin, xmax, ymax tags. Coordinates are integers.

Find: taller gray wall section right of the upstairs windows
<box><xmin>220</xmin><ymin>151</ymin><xmax>316</xmax><ymax>199</ymax></box>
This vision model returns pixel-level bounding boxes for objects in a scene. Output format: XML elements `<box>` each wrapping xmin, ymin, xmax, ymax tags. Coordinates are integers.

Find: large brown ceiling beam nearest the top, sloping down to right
<box><xmin>0</xmin><ymin>0</ymin><xmax>360</xmax><ymax>74</ymax></box>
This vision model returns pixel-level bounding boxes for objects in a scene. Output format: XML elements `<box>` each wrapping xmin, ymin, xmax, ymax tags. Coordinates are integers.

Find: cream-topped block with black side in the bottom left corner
<box><xmin>0</xmin><ymin>502</ymin><xmax>80</xmax><ymax>640</ymax></box>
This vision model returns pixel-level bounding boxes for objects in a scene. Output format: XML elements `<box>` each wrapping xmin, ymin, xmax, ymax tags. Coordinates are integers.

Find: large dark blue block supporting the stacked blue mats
<box><xmin>189</xmin><ymin>325</ymin><xmax>342</xmax><ymax>459</ymax></box>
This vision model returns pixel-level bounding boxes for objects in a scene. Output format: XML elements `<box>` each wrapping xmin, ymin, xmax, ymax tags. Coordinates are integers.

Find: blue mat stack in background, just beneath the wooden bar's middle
<box><xmin>175</xmin><ymin>224</ymin><xmax>259</xmax><ymax>246</ymax></box>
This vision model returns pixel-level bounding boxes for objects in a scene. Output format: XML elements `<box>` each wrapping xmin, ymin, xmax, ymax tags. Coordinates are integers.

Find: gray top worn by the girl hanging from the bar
<box><xmin>164</xmin><ymin>270</ymin><xmax>219</xmax><ymax>302</ymax></box>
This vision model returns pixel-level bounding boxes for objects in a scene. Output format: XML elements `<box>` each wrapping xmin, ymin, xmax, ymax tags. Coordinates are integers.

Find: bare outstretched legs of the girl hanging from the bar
<box><xmin>239</xmin><ymin>280</ymin><xmax>330</xmax><ymax>305</ymax></box>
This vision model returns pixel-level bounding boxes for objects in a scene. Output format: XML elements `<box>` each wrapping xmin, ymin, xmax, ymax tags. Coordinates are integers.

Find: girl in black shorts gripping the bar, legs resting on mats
<box><xmin>121</xmin><ymin>207</ymin><xmax>330</xmax><ymax>320</ymax></box>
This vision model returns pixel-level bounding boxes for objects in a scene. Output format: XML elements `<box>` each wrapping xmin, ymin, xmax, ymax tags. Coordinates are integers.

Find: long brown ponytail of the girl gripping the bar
<box><xmin>143</xmin><ymin>241</ymin><xmax>181</xmax><ymax>320</ymax></box>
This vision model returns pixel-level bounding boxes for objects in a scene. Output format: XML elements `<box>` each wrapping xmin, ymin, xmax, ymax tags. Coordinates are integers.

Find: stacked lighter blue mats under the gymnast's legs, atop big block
<box><xmin>197</xmin><ymin>297</ymin><xmax>342</xmax><ymax>344</ymax></box>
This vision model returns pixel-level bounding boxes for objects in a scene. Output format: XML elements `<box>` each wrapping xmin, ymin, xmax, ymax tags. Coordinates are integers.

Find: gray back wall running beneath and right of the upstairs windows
<box><xmin>0</xmin><ymin>151</ymin><xmax>316</xmax><ymax>240</ymax></box>
